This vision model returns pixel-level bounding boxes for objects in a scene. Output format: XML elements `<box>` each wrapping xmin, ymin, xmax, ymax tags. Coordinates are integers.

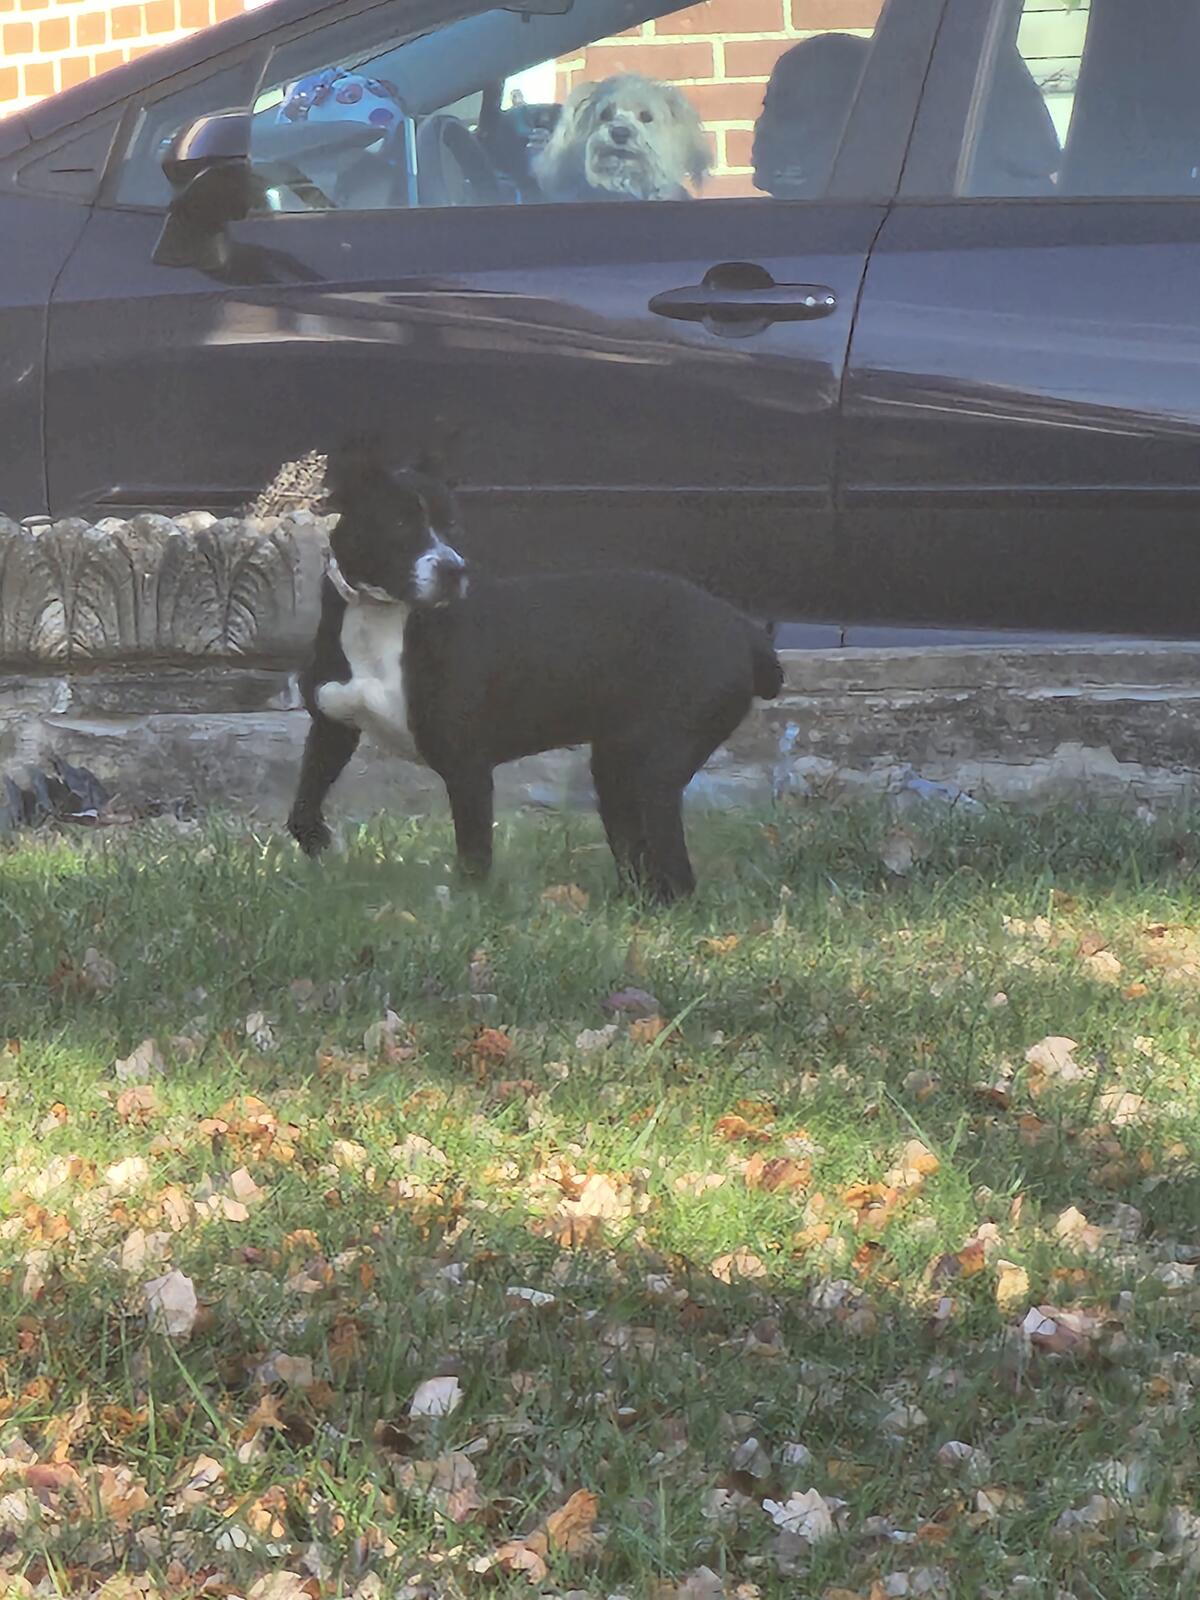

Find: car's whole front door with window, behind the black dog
<box><xmin>48</xmin><ymin>0</ymin><xmax>942</xmax><ymax>618</ymax></box>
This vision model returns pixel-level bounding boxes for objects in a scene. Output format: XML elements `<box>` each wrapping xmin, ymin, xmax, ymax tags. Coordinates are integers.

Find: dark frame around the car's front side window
<box><xmin>93</xmin><ymin>0</ymin><xmax>954</xmax><ymax>226</ymax></box>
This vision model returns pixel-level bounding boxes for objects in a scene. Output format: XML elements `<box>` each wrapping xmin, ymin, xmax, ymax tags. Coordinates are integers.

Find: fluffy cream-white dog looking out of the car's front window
<box><xmin>533</xmin><ymin>72</ymin><xmax>712</xmax><ymax>200</ymax></box>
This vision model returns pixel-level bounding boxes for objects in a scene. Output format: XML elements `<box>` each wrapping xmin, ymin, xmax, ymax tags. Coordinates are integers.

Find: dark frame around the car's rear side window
<box><xmin>896</xmin><ymin>0</ymin><xmax>1200</xmax><ymax>210</ymax></box>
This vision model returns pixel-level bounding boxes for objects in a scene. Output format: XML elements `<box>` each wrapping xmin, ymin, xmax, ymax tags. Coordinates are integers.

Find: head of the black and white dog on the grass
<box><xmin>326</xmin><ymin>445</ymin><xmax>467</xmax><ymax>605</ymax></box>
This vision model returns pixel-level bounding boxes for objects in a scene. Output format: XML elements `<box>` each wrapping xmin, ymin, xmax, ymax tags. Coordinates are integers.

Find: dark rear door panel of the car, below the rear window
<box><xmin>840</xmin><ymin>200</ymin><xmax>1200</xmax><ymax>637</ymax></box>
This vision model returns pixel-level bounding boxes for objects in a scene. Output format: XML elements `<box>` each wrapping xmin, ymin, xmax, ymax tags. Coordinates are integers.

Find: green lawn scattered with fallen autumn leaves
<box><xmin>0</xmin><ymin>803</ymin><xmax>1200</xmax><ymax>1600</ymax></box>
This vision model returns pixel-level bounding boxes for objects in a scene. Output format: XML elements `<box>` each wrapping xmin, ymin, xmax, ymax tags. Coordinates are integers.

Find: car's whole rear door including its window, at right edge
<box><xmin>840</xmin><ymin>0</ymin><xmax>1200</xmax><ymax>637</ymax></box>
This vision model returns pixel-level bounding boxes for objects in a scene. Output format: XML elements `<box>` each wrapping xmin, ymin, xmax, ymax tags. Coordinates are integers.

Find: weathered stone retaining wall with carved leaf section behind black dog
<box><xmin>0</xmin><ymin>512</ymin><xmax>1200</xmax><ymax>819</ymax></box>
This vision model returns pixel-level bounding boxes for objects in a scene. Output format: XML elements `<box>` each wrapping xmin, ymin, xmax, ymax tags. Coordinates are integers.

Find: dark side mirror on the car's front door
<box><xmin>154</xmin><ymin>110</ymin><xmax>254</xmax><ymax>272</ymax></box>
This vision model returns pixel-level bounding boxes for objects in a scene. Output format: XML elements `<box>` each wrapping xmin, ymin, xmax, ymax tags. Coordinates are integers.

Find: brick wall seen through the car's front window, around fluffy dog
<box><xmin>557</xmin><ymin>0</ymin><xmax>882</xmax><ymax>195</ymax></box>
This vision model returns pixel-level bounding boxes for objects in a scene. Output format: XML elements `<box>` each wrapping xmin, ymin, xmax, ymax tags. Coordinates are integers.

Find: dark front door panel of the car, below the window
<box><xmin>48</xmin><ymin>203</ymin><xmax>883</xmax><ymax>614</ymax></box>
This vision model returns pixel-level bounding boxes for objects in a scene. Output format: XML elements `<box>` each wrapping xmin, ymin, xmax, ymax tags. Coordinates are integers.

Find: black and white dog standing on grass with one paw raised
<box><xmin>288</xmin><ymin>446</ymin><xmax>782</xmax><ymax>901</ymax></box>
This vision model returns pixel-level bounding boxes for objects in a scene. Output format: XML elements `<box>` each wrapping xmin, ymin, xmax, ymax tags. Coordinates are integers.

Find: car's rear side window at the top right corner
<box><xmin>958</xmin><ymin>0</ymin><xmax>1200</xmax><ymax>197</ymax></box>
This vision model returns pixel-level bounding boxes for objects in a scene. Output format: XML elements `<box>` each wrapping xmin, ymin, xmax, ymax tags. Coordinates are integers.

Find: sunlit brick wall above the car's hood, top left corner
<box><xmin>0</xmin><ymin>0</ymin><xmax>246</xmax><ymax>117</ymax></box>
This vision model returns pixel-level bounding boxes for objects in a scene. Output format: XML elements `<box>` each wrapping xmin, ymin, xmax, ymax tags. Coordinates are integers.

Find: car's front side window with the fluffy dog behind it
<box><xmin>118</xmin><ymin>0</ymin><xmax>882</xmax><ymax>214</ymax></box>
